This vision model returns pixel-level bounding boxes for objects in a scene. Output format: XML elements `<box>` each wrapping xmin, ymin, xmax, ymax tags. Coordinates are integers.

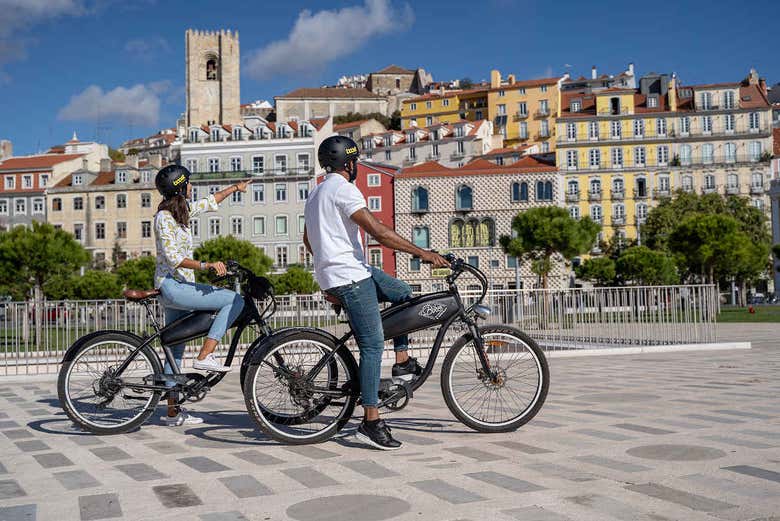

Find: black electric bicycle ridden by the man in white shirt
<box><xmin>243</xmin><ymin>255</ymin><xmax>550</xmax><ymax>444</ymax></box>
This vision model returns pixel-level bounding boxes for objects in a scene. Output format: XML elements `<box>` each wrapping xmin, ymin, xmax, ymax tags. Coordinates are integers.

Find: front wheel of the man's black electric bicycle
<box><xmin>441</xmin><ymin>326</ymin><xmax>550</xmax><ymax>432</ymax></box>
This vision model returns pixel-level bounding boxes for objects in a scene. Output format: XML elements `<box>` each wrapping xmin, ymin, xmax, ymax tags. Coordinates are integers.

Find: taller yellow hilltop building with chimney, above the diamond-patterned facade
<box><xmin>487</xmin><ymin>70</ymin><xmax>566</xmax><ymax>152</ymax></box>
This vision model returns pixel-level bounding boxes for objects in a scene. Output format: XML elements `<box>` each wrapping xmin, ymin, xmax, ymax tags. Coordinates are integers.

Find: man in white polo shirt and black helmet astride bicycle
<box><xmin>303</xmin><ymin>136</ymin><xmax>449</xmax><ymax>450</ymax></box>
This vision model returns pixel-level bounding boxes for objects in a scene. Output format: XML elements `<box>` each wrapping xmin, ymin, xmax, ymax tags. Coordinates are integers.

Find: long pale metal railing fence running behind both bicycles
<box><xmin>0</xmin><ymin>285</ymin><xmax>719</xmax><ymax>376</ymax></box>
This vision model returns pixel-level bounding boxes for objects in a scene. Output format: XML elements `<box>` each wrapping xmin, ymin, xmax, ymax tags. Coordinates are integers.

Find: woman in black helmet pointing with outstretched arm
<box><xmin>154</xmin><ymin>165</ymin><xmax>250</xmax><ymax>425</ymax></box>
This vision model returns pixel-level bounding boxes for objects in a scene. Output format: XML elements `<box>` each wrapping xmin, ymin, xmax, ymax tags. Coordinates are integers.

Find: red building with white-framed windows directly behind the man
<box><xmin>317</xmin><ymin>162</ymin><xmax>399</xmax><ymax>277</ymax></box>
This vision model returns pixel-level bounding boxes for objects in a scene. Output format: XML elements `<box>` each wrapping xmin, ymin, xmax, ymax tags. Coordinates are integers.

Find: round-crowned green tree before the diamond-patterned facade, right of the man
<box><xmin>500</xmin><ymin>206</ymin><xmax>601</xmax><ymax>288</ymax></box>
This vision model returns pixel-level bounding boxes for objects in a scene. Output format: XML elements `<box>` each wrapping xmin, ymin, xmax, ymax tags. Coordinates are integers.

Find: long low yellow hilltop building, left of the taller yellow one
<box><xmin>401</xmin><ymin>88</ymin><xmax>488</xmax><ymax>128</ymax></box>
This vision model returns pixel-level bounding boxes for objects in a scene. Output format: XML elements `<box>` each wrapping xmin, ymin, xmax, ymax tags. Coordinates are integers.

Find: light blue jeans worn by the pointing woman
<box><xmin>160</xmin><ymin>277</ymin><xmax>244</xmax><ymax>374</ymax></box>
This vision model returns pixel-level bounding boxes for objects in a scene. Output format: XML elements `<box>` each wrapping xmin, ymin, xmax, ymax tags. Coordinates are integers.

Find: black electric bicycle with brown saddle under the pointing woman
<box><xmin>57</xmin><ymin>261</ymin><xmax>276</xmax><ymax>434</ymax></box>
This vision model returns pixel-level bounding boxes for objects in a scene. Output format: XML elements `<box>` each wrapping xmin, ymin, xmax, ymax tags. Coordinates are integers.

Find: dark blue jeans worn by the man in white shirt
<box><xmin>327</xmin><ymin>268</ymin><xmax>412</xmax><ymax>407</ymax></box>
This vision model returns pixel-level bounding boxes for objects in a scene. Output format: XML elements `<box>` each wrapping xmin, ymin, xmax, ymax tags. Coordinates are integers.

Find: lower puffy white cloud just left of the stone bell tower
<box><xmin>57</xmin><ymin>82</ymin><xmax>165</xmax><ymax>126</ymax></box>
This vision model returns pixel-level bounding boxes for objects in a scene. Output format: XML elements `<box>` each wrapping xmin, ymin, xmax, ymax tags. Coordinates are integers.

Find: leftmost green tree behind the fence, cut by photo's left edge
<box><xmin>0</xmin><ymin>222</ymin><xmax>89</xmax><ymax>300</ymax></box>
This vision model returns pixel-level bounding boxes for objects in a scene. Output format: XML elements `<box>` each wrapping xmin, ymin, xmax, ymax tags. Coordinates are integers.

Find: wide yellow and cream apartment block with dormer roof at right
<box><xmin>556</xmin><ymin>69</ymin><xmax>772</xmax><ymax>246</ymax></box>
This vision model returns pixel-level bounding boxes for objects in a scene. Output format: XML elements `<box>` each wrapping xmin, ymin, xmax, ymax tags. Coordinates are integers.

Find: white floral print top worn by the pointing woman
<box><xmin>154</xmin><ymin>194</ymin><xmax>218</xmax><ymax>288</ymax></box>
